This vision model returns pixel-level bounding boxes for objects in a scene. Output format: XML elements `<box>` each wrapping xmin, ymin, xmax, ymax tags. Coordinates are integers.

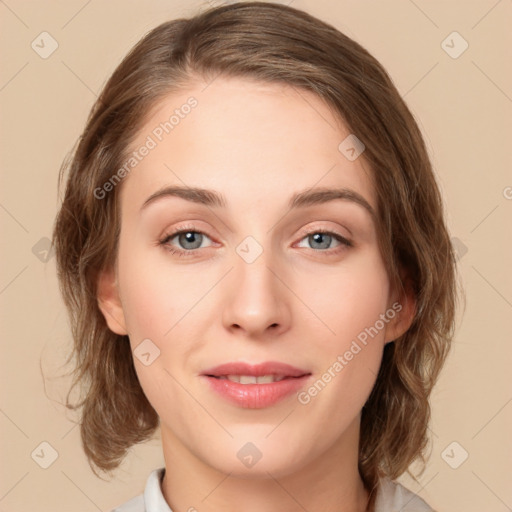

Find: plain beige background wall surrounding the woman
<box><xmin>0</xmin><ymin>0</ymin><xmax>512</xmax><ymax>512</ymax></box>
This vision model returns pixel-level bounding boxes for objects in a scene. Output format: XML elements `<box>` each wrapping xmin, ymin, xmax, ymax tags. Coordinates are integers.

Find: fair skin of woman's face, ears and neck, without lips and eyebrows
<box><xmin>98</xmin><ymin>77</ymin><xmax>414</xmax><ymax>512</ymax></box>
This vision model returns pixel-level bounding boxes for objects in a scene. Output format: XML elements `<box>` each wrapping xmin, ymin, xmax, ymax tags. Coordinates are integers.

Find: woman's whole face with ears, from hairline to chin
<box><xmin>99</xmin><ymin>77</ymin><xmax>414</xmax><ymax>476</ymax></box>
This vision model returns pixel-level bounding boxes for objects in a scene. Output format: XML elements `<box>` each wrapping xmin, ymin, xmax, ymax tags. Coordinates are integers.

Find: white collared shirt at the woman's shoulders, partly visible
<box><xmin>112</xmin><ymin>468</ymin><xmax>435</xmax><ymax>512</ymax></box>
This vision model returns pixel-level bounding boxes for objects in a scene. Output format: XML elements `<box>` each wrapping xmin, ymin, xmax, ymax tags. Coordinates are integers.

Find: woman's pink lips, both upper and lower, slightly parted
<box><xmin>201</xmin><ymin>361</ymin><xmax>311</xmax><ymax>409</ymax></box>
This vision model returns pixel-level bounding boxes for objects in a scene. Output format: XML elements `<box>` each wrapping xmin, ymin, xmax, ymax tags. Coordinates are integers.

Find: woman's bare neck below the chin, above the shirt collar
<box><xmin>162</xmin><ymin>418</ymin><xmax>368</xmax><ymax>512</ymax></box>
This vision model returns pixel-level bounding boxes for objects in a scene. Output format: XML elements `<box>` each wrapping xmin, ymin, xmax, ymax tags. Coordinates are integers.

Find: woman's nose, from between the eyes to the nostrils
<box><xmin>222</xmin><ymin>251</ymin><xmax>291</xmax><ymax>339</ymax></box>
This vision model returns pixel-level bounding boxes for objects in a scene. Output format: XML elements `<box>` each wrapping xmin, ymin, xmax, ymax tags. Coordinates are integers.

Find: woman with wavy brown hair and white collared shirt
<box><xmin>54</xmin><ymin>2</ymin><xmax>456</xmax><ymax>512</ymax></box>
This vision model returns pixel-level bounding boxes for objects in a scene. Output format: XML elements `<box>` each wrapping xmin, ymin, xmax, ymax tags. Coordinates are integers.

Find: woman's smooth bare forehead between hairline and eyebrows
<box><xmin>122</xmin><ymin>77</ymin><xmax>376</xmax><ymax>217</ymax></box>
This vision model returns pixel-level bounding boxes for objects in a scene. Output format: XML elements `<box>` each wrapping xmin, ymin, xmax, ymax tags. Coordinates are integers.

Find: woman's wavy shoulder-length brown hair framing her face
<box><xmin>53</xmin><ymin>2</ymin><xmax>457</xmax><ymax>510</ymax></box>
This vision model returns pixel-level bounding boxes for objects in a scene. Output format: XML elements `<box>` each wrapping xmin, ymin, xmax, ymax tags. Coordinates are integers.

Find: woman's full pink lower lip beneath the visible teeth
<box><xmin>203</xmin><ymin>375</ymin><xmax>311</xmax><ymax>409</ymax></box>
